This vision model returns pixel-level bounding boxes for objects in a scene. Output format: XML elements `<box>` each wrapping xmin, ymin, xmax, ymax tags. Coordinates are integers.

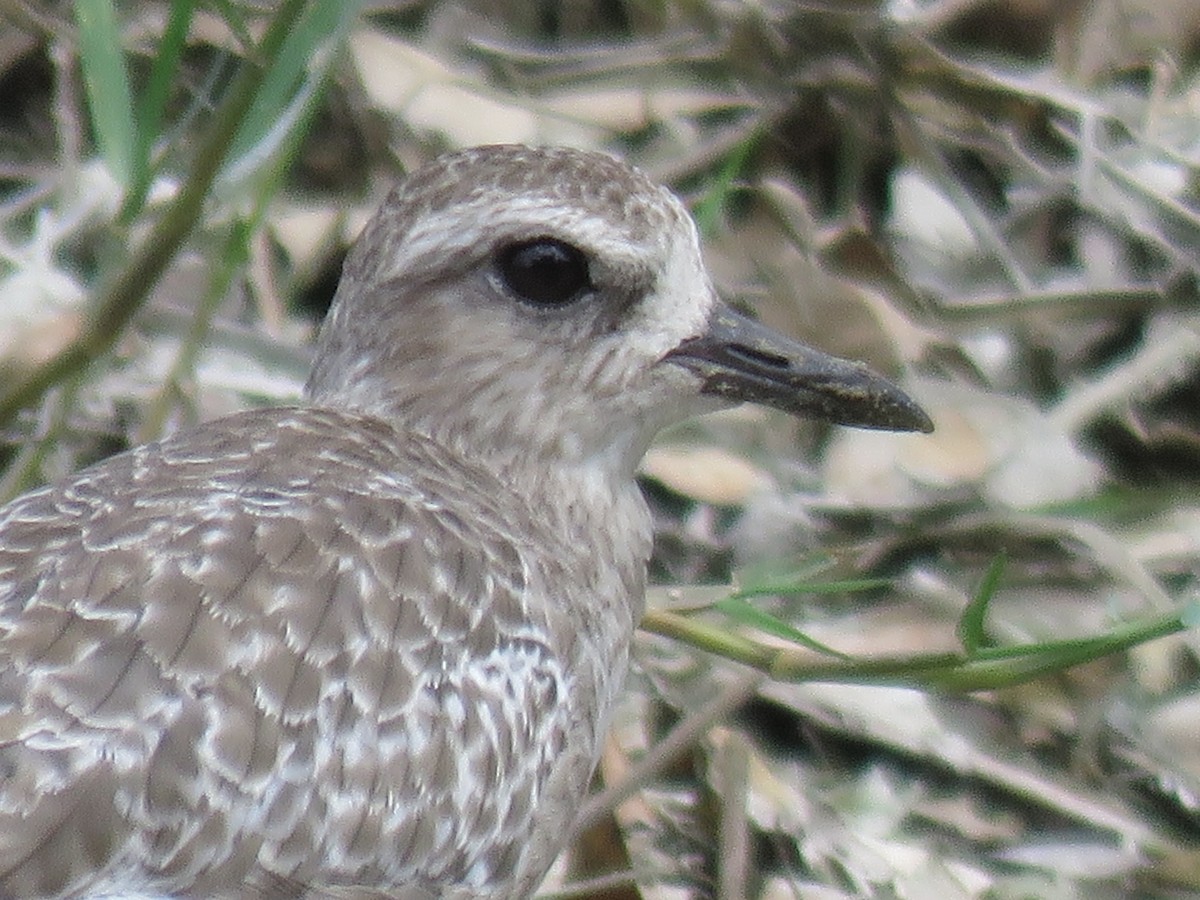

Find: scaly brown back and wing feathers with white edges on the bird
<box><xmin>0</xmin><ymin>409</ymin><xmax>580</xmax><ymax>895</ymax></box>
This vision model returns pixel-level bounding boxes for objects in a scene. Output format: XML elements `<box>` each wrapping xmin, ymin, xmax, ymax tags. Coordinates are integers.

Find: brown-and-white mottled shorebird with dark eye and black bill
<box><xmin>0</xmin><ymin>145</ymin><xmax>931</xmax><ymax>900</ymax></box>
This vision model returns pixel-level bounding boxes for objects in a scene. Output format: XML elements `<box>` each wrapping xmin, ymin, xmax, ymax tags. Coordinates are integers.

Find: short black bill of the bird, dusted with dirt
<box><xmin>664</xmin><ymin>304</ymin><xmax>934</xmax><ymax>432</ymax></box>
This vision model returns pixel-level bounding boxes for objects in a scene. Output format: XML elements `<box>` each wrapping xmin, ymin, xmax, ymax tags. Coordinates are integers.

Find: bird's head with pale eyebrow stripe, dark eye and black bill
<box><xmin>307</xmin><ymin>145</ymin><xmax>931</xmax><ymax>475</ymax></box>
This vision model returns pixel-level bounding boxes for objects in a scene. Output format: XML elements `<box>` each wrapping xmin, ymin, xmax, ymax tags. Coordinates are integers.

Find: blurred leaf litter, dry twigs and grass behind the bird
<box><xmin>0</xmin><ymin>0</ymin><xmax>1200</xmax><ymax>900</ymax></box>
